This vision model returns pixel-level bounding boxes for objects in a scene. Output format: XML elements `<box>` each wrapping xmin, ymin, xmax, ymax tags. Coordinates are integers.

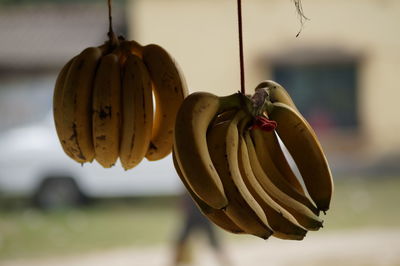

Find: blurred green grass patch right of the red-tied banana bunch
<box><xmin>324</xmin><ymin>177</ymin><xmax>400</xmax><ymax>230</ymax></box>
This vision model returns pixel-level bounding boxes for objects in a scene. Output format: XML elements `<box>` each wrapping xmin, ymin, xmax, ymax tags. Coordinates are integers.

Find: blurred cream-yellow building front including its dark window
<box><xmin>128</xmin><ymin>0</ymin><xmax>400</xmax><ymax>160</ymax></box>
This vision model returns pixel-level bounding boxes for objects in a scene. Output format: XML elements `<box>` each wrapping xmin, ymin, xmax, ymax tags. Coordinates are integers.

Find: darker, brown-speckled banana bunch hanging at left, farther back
<box><xmin>53</xmin><ymin>38</ymin><xmax>187</xmax><ymax>169</ymax></box>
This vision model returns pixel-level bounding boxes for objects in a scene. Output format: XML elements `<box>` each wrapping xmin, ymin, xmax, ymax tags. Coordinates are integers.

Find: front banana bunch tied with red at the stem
<box><xmin>173</xmin><ymin>81</ymin><xmax>333</xmax><ymax>240</ymax></box>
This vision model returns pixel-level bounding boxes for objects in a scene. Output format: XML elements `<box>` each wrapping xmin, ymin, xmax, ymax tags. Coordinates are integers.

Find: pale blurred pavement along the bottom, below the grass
<box><xmin>0</xmin><ymin>228</ymin><xmax>400</xmax><ymax>266</ymax></box>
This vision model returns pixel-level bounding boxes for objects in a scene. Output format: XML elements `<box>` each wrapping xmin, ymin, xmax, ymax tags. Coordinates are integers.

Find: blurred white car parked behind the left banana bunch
<box><xmin>0</xmin><ymin>116</ymin><xmax>182</xmax><ymax>208</ymax></box>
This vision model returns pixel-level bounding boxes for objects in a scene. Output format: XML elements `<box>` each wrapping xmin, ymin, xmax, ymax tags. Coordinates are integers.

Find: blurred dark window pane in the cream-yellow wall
<box><xmin>272</xmin><ymin>62</ymin><xmax>359</xmax><ymax>132</ymax></box>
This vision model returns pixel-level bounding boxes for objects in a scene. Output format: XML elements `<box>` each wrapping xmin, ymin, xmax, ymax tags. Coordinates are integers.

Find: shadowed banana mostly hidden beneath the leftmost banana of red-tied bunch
<box><xmin>172</xmin><ymin>150</ymin><xmax>243</xmax><ymax>234</ymax></box>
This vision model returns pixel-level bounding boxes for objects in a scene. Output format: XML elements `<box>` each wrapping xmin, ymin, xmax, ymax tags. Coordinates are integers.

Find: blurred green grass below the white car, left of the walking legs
<box><xmin>0</xmin><ymin>197</ymin><xmax>179</xmax><ymax>264</ymax></box>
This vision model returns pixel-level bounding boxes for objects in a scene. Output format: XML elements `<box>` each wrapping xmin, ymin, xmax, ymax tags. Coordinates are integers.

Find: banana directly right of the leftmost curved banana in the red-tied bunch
<box><xmin>207</xmin><ymin>111</ymin><xmax>272</xmax><ymax>239</ymax></box>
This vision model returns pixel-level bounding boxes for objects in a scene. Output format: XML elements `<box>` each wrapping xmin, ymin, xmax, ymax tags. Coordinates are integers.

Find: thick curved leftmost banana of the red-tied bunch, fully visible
<box><xmin>174</xmin><ymin>92</ymin><xmax>241</xmax><ymax>209</ymax></box>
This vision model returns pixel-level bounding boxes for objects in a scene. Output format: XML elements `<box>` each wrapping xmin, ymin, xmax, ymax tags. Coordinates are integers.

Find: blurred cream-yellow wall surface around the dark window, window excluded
<box><xmin>129</xmin><ymin>0</ymin><xmax>400</xmax><ymax>155</ymax></box>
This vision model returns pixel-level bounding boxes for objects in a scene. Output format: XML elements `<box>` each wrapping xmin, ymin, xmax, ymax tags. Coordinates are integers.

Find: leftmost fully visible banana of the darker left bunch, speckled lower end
<box><xmin>59</xmin><ymin>47</ymin><xmax>101</xmax><ymax>163</ymax></box>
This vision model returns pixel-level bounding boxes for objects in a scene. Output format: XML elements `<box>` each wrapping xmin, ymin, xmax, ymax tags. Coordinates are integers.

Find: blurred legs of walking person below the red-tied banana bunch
<box><xmin>172</xmin><ymin>192</ymin><xmax>232</xmax><ymax>266</ymax></box>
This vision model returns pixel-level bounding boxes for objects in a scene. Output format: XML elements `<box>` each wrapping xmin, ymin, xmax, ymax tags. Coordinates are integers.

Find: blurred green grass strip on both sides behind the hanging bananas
<box><xmin>0</xmin><ymin>177</ymin><xmax>400</xmax><ymax>264</ymax></box>
